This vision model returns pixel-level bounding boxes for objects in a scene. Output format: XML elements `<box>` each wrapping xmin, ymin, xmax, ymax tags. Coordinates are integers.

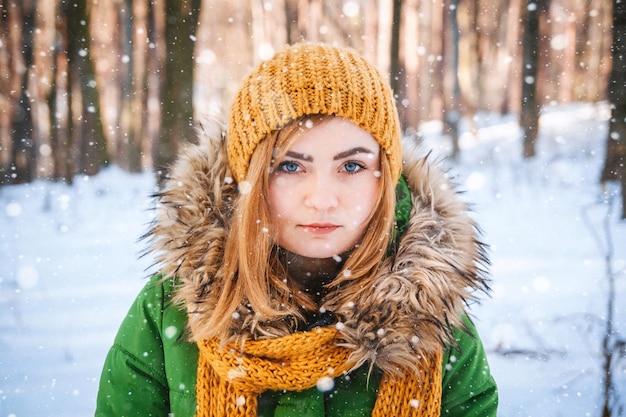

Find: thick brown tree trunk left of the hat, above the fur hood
<box><xmin>154</xmin><ymin>0</ymin><xmax>200</xmax><ymax>183</ymax></box>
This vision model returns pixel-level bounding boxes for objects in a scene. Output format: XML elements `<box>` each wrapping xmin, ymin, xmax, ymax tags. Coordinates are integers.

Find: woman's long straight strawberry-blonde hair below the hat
<box><xmin>208</xmin><ymin>115</ymin><xmax>396</xmax><ymax>340</ymax></box>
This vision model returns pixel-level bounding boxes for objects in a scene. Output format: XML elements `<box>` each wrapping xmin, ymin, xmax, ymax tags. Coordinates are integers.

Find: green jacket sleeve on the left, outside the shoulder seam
<box><xmin>95</xmin><ymin>277</ymin><xmax>169</xmax><ymax>417</ymax></box>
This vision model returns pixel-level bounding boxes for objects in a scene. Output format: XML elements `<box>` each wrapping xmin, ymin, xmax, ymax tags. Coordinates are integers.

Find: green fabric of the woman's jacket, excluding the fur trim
<box><xmin>95</xmin><ymin>277</ymin><xmax>498</xmax><ymax>417</ymax></box>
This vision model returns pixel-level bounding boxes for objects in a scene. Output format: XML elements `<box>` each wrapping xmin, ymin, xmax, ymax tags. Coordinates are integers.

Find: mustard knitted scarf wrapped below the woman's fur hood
<box><xmin>196</xmin><ymin>327</ymin><xmax>441</xmax><ymax>417</ymax></box>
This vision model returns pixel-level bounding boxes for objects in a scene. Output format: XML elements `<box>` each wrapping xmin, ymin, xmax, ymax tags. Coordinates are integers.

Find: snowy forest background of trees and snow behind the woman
<box><xmin>0</xmin><ymin>0</ymin><xmax>626</xmax><ymax>417</ymax></box>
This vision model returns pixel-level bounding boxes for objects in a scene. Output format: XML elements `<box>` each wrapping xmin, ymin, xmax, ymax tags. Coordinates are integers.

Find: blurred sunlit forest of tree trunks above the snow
<box><xmin>0</xmin><ymin>0</ymin><xmax>626</xmax><ymax>210</ymax></box>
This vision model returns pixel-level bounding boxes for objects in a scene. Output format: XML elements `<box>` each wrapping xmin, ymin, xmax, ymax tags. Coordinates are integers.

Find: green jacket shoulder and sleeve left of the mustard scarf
<box><xmin>96</xmin><ymin>276</ymin><xmax>197</xmax><ymax>416</ymax></box>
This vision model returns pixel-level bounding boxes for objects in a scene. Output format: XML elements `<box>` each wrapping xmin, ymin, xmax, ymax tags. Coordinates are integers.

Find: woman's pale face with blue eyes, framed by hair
<box><xmin>269</xmin><ymin>117</ymin><xmax>381</xmax><ymax>258</ymax></box>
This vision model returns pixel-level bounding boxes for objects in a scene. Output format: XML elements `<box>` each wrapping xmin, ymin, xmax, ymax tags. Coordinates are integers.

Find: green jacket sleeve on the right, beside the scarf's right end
<box><xmin>441</xmin><ymin>317</ymin><xmax>498</xmax><ymax>417</ymax></box>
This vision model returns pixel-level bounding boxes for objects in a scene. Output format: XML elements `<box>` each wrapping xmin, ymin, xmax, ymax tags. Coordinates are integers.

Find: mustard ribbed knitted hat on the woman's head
<box><xmin>227</xmin><ymin>43</ymin><xmax>402</xmax><ymax>182</ymax></box>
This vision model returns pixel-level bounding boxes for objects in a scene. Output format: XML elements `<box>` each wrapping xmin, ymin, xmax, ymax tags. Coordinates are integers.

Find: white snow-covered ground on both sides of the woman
<box><xmin>0</xmin><ymin>104</ymin><xmax>626</xmax><ymax>417</ymax></box>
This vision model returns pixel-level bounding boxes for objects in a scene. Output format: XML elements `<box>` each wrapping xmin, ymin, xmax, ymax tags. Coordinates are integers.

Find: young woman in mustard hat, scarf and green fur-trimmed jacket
<box><xmin>96</xmin><ymin>44</ymin><xmax>497</xmax><ymax>417</ymax></box>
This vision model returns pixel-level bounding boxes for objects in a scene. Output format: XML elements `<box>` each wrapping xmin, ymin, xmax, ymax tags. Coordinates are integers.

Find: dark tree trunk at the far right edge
<box><xmin>600</xmin><ymin>0</ymin><xmax>626</xmax><ymax>219</ymax></box>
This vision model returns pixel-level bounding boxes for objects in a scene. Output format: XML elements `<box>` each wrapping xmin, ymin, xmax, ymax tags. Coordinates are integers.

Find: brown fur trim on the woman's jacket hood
<box><xmin>146</xmin><ymin>114</ymin><xmax>488</xmax><ymax>372</ymax></box>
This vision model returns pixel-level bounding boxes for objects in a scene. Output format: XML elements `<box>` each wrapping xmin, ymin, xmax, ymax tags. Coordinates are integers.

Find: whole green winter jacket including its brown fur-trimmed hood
<box><xmin>95</xmin><ymin>118</ymin><xmax>498</xmax><ymax>417</ymax></box>
